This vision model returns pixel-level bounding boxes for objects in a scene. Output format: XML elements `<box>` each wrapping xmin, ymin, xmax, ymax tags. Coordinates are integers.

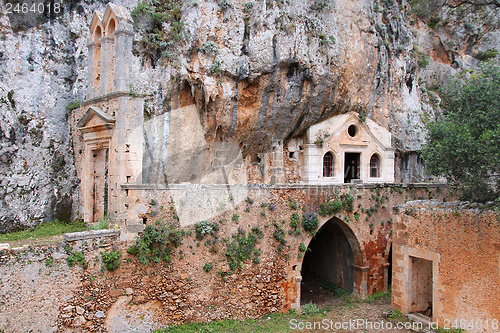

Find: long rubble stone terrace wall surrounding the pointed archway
<box><xmin>0</xmin><ymin>186</ymin><xmax>454</xmax><ymax>332</ymax></box>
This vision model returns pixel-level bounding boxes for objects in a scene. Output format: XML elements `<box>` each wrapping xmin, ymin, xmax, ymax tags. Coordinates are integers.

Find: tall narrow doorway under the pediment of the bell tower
<box><xmin>92</xmin><ymin>149</ymin><xmax>108</xmax><ymax>222</ymax></box>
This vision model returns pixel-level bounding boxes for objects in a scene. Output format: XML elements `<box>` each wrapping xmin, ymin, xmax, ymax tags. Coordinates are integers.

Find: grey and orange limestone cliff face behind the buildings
<box><xmin>0</xmin><ymin>0</ymin><xmax>500</xmax><ymax>231</ymax></box>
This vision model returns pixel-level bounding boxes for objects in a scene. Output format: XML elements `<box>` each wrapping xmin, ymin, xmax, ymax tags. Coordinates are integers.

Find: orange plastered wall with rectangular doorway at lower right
<box><xmin>392</xmin><ymin>202</ymin><xmax>500</xmax><ymax>332</ymax></box>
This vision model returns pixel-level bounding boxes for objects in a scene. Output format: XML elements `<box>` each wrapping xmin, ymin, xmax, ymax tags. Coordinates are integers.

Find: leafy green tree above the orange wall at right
<box><xmin>423</xmin><ymin>64</ymin><xmax>500</xmax><ymax>202</ymax></box>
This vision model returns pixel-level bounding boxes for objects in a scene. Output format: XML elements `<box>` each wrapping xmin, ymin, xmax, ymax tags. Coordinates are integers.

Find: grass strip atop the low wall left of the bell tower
<box><xmin>0</xmin><ymin>220</ymin><xmax>87</xmax><ymax>242</ymax></box>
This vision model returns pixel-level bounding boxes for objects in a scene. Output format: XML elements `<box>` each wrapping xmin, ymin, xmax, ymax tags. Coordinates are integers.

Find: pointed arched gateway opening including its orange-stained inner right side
<box><xmin>301</xmin><ymin>217</ymin><xmax>368</xmax><ymax>303</ymax></box>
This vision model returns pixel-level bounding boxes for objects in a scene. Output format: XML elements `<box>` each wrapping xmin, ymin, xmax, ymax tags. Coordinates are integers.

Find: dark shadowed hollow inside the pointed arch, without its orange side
<box><xmin>301</xmin><ymin>218</ymin><xmax>359</xmax><ymax>304</ymax></box>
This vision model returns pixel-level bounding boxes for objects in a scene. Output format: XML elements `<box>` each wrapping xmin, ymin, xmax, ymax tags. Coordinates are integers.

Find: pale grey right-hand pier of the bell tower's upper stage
<box><xmin>114</xmin><ymin>22</ymin><xmax>134</xmax><ymax>91</ymax></box>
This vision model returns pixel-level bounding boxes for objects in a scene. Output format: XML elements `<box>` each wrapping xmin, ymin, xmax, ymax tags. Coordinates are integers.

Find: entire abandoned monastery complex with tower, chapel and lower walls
<box><xmin>0</xmin><ymin>1</ymin><xmax>500</xmax><ymax>332</ymax></box>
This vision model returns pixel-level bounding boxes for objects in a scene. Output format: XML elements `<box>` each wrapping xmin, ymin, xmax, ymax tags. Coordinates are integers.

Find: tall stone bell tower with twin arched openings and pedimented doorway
<box><xmin>77</xmin><ymin>3</ymin><xmax>144</xmax><ymax>231</ymax></box>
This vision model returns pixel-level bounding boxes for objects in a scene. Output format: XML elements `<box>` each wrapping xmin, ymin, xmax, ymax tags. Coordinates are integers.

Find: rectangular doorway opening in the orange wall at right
<box><xmin>410</xmin><ymin>257</ymin><xmax>433</xmax><ymax>318</ymax></box>
